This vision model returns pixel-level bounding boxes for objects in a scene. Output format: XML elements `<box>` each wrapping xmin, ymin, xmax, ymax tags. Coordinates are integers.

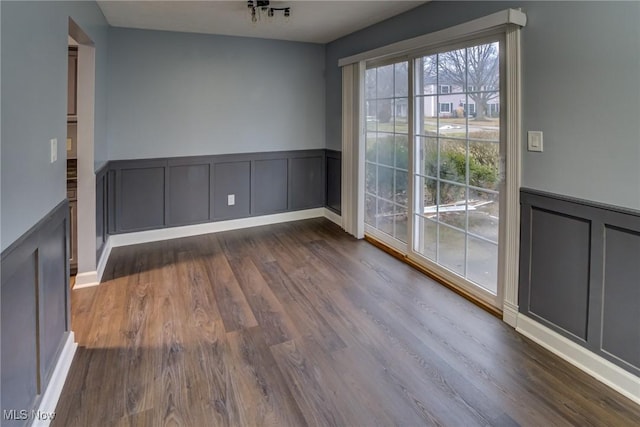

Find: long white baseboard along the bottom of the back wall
<box><xmin>105</xmin><ymin>208</ymin><xmax>325</xmax><ymax>252</ymax></box>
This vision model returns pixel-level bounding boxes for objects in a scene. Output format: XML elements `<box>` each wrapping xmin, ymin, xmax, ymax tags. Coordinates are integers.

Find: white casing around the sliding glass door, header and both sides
<box><xmin>338</xmin><ymin>9</ymin><xmax>527</xmax><ymax>327</ymax></box>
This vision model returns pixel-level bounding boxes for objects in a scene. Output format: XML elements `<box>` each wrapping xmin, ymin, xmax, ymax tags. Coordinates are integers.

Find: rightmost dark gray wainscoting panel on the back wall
<box><xmin>289</xmin><ymin>155</ymin><xmax>325</xmax><ymax>210</ymax></box>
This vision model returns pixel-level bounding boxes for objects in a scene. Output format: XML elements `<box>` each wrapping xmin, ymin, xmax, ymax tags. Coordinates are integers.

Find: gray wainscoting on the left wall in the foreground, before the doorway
<box><xmin>0</xmin><ymin>200</ymin><xmax>69</xmax><ymax>425</ymax></box>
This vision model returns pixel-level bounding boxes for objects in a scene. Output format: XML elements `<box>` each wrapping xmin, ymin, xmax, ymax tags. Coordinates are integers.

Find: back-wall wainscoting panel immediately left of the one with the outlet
<box><xmin>167</xmin><ymin>161</ymin><xmax>211</xmax><ymax>226</ymax></box>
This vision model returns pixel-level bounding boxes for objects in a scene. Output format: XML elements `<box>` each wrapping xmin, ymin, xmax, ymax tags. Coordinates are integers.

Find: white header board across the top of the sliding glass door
<box><xmin>338</xmin><ymin>9</ymin><xmax>527</xmax><ymax>67</ymax></box>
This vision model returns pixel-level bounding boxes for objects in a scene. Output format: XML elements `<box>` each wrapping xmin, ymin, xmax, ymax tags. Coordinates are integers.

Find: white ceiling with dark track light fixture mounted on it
<box><xmin>98</xmin><ymin>0</ymin><xmax>427</xmax><ymax>43</ymax></box>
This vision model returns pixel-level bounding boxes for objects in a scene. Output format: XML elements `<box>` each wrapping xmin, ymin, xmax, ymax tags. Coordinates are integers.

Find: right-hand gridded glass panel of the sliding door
<box><xmin>411</xmin><ymin>42</ymin><xmax>501</xmax><ymax>295</ymax></box>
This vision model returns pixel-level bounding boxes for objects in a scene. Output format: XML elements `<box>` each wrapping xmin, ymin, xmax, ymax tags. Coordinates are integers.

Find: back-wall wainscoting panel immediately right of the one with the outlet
<box><xmin>251</xmin><ymin>159</ymin><xmax>288</xmax><ymax>215</ymax></box>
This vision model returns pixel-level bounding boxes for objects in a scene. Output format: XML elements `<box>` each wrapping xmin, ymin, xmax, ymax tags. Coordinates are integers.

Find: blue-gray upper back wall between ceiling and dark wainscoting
<box><xmin>108</xmin><ymin>28</ymin><xmax>325</xmax><ymax>160</ymax></box>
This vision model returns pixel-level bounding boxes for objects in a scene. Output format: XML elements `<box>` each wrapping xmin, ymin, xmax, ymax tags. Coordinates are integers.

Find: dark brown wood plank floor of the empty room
<box><xmin>53</xmin><ymin>219</ymin><xmax>640</xmax><ymax>426</ymax></box>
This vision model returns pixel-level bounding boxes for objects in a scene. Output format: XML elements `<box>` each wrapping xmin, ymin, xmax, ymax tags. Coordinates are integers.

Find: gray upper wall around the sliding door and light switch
<box><xmin>326</xmin><ymin>1</ymin><xmax>640</xmax><ymax>209</ymax></box>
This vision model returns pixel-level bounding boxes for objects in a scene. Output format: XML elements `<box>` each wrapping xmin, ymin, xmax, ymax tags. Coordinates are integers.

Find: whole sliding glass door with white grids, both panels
<box><xmin>364</xmin><ymin>40</ymin><xmax>504</xmax><ymax>306</ymax></box>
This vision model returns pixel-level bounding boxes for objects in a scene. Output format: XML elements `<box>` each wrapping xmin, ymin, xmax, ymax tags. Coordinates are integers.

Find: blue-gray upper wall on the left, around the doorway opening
<box><xmin>0</xmin><ymin>1</ymin><xmax>108</xmax><ymax>250</ymax></box>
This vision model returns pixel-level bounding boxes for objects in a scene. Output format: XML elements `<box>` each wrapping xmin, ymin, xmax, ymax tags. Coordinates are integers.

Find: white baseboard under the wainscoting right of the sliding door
<box><xmin>516</xmin><ymin>314</ymin><xmax>640</xmax><ymax>404</ymax></box>
